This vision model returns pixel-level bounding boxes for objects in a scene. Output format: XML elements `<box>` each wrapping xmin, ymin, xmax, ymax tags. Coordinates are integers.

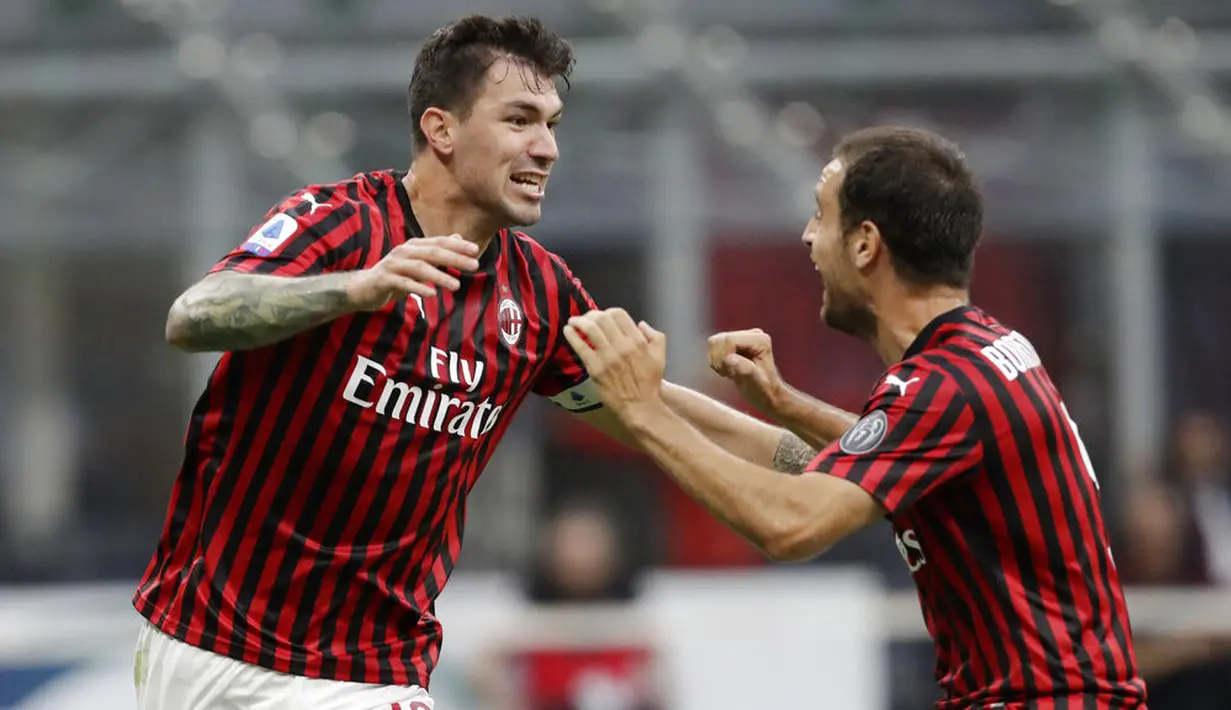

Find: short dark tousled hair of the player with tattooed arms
<box><xmin>406</xmin><ymin>15</ymin><xmax>576</xmax><ymax>150</ymax></box>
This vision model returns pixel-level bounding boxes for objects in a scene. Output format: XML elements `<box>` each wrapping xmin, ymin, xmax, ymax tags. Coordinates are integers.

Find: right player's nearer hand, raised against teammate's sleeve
<box><xmin>564</xmin><ymin>308</ymin><xmax>667</xmax><ymax>417</ymax></box>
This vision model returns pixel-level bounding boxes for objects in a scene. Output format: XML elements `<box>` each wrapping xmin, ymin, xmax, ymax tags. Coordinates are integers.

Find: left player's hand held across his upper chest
<box><xmin>346</xmin><ymin>235</ymin><xmax>479</xmax><ymax>310</ymax></box>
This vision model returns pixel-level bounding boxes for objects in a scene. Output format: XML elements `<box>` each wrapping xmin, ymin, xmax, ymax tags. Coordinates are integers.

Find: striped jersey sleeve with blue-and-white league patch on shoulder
<box><xmin>211</xmin><ymin>187</ymin><xmax>364</xmax><ymax>276</ymax></box>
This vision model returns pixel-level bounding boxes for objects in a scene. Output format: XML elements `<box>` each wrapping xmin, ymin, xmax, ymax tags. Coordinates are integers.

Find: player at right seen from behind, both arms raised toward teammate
<box><xmin>565</xmin><ymin>128</ymin><xmax>1146</xmax><ymax>710</ymax></box>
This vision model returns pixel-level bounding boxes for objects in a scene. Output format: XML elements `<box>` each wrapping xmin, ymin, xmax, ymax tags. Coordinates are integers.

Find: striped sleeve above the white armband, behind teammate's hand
<box><xmin>534</xmin><ymin>255</ymin><xmax>603</xmax><ymax>413</ymax></box>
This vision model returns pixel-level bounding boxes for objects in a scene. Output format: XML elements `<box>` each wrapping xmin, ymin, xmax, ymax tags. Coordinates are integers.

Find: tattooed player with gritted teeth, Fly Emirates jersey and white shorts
<box><xmin>134</xmin><ymin>16</ymin><xmax>815</xmax><ymax>710</ymax></box>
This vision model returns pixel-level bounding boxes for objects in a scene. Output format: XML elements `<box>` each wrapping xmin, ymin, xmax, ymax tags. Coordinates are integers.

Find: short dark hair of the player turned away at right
<box><xmin>833</xmin><ymin>127</ymin><xmax>984</xmax><ymax>288</ymax></box>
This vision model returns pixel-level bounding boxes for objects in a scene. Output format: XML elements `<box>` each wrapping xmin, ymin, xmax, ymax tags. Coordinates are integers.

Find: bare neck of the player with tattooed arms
<box><xmin>401</xmin><ymin>160</ymin><xmax>505</xmax><ymax>250</ymax></box>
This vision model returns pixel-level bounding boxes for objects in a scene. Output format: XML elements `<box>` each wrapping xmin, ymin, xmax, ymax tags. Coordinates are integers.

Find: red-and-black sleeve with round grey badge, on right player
<box><xmin>808</xmin><ymin>365</ymin><xmax>982</xmax><ymax>517</ymax></box>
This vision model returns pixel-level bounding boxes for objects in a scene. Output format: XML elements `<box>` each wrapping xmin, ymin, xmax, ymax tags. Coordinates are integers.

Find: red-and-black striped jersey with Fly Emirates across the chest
<box><xmin>134</xmin><ymin>171</ymin><xmax>597</xmax><ymax>687</ymax></box>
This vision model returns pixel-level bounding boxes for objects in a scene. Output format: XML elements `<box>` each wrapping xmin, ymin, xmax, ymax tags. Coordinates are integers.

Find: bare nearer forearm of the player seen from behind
<box><xmin>628</xmin><ymin>405</ymin><xmax>816</xmax><ymax>560</ymax></box>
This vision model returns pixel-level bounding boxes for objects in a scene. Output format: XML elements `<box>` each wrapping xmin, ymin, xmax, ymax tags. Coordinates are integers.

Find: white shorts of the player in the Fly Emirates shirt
<box><xmin>133</xmin><ymin>621</ymin><xmax>433</xmax><ymax>710</ymax></box>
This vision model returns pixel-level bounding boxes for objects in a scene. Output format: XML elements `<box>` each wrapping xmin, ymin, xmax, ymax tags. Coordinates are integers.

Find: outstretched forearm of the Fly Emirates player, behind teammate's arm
<box><xmin>662</xmin><ymin>383</ymin><xmax>816</xmax><ymax>474</ymax></box>
